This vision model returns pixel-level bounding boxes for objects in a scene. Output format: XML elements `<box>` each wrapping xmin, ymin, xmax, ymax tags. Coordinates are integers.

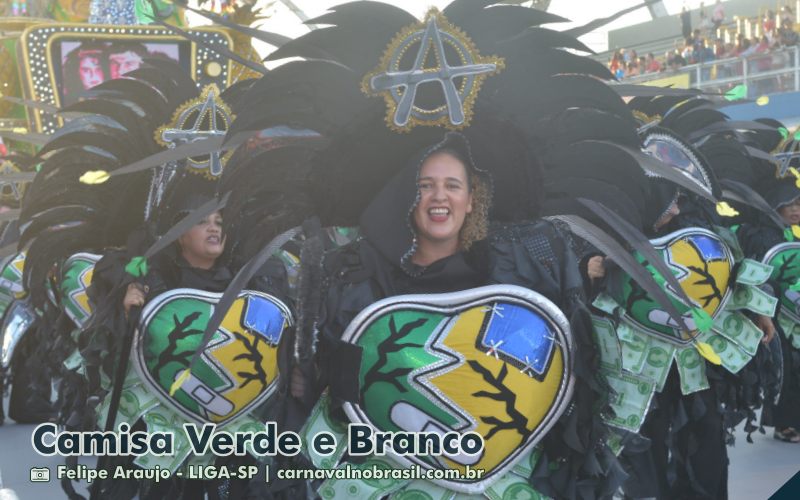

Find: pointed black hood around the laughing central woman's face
<box><xmin>360</xmin><ymin>132</ymin><xmax>491</xmax><ymax>274</ymax></box>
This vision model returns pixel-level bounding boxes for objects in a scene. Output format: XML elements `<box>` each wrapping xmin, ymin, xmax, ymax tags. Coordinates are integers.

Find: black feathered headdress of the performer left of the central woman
<box><xmin>19</xmin><ymin>60</ymin><xmax>230</xmax><ymax>296</ymax></box>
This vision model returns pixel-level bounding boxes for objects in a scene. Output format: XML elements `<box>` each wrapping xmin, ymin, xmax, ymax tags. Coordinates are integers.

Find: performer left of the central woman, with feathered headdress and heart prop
<box><xmin>8</xmin><ymin>60</ymin><xmax>291</xmax><ymax>498</ymax></box>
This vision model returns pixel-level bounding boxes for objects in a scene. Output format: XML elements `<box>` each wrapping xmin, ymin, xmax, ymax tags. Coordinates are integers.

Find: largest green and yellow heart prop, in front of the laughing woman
<box><xmin>343</xmin><ymin>285</ymin><xmax>573</xmax><ymax>493</ymax></box>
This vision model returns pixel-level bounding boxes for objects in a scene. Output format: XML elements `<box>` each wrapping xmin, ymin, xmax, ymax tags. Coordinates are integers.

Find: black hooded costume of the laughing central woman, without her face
<box><xmin>290</xmin><ymin>132</ymin><xmax>622</xmax><ymax>498</ymax></box>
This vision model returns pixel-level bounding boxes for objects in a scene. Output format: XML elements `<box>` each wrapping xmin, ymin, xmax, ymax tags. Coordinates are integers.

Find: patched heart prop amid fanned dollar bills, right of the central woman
<box><xmin>610</xmin><ymin>227</ymin><xmax>734</xmax><ymax>345</ymax></box>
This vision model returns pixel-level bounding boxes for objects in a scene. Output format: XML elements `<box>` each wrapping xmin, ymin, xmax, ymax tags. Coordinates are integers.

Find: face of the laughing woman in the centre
<box><xmin>414</xmin><ymin>149</ymin><xmax>472</xmax><ymax>249</ymax></box>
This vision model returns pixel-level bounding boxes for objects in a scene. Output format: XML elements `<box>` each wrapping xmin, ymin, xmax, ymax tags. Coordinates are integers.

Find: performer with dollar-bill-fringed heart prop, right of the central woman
<box><xmin>594</xmin><ymin>97</ymin><xmax>774</xmax><ymax>498</ymax></box>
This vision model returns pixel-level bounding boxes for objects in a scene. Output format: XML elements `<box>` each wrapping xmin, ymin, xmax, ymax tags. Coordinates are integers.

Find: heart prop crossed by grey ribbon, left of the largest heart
<box><xmin>133</xmin><ymin>288</ymin><xmax>292</xmax><ymax>424</ymax></box>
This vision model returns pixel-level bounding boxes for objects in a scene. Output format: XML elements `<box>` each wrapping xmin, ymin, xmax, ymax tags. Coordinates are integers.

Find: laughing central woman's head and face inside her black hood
<box><xmin>361</xmin><ymin>133</ymin><xmax>491</xmax><ymax>286</ymax></box>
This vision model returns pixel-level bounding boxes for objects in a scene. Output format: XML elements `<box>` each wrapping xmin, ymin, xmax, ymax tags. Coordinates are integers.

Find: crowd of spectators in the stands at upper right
<box><xmin>608</xmin><ymin>0</ymin><xmax>800</xmax><ymax>79</ymax></box>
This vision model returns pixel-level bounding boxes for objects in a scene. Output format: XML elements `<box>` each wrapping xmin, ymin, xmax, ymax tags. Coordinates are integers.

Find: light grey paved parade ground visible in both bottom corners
<box><xmin>0</xmin><ymin>401</ymin><xmax>800</xmax><ymax>500</ymax></box>
